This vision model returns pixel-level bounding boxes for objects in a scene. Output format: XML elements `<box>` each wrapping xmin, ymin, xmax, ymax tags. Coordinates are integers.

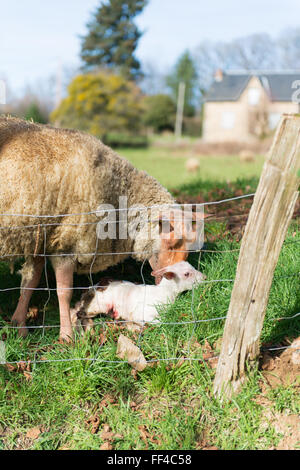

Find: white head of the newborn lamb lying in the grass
<box><xmin>151</xmin><ymin>261</ymin><xmax>206</xmax><ymax>293</ymax></box>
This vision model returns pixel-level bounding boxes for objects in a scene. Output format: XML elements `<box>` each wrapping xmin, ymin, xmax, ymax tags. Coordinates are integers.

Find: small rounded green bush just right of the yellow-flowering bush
<box><xmin>144</xmin><ymin>94</ymin><xmax>176</xmax><ymax>132</ymax></box>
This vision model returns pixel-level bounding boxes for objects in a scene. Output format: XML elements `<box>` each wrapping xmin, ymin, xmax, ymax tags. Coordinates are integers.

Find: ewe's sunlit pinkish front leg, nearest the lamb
<box><xmin>54</xmin><ymin>260</ymin><xmax>74</xmax><ymax>342</ymax></box>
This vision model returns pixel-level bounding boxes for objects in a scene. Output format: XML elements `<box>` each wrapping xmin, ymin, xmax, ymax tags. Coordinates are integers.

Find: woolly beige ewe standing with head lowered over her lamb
<box><xmin>0</xmin><ymin>117</ymin><xmax>203</xmax><ymax>341</ymax></box>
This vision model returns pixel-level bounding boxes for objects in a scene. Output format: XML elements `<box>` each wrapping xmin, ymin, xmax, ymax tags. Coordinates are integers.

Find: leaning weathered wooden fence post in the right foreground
<box><xmin>214</xmin><ymin>115</ymin><xmax>300</xmax><ymax>397</ymax></box>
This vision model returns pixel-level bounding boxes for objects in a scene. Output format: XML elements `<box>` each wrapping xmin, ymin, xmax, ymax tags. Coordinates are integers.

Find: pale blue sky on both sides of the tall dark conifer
<box><xmin>0</xmin><ymin>0</ymin><xmax>300</xmax><ymax>96</ymax></box>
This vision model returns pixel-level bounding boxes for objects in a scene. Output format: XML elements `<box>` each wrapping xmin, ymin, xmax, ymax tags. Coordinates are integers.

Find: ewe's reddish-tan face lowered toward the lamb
<box><xmin>149</xmin><ymin>209</ymin><xmax>204</xmax><ymax>284</ymax></box>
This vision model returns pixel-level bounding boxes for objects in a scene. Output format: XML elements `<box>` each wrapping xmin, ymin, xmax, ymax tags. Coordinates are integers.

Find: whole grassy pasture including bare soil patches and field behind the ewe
<box><xmin>0</xmin><ymin>161</ymin><xmax>300</xmax><ymax>450</ymax></box>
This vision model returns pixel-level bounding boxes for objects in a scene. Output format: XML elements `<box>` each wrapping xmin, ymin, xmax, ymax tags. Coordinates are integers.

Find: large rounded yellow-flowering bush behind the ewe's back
<box><xmin>51</xmin><ymin>71</ymin><xmax>143</xmax><ymax>138</ymax></box>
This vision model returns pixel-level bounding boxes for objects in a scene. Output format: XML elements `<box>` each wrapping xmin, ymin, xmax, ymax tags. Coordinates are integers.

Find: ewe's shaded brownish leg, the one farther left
<box><xmin>11</xmin><ymin>257</ymin><xmax>44</xmax><ymax>337</ymax></box>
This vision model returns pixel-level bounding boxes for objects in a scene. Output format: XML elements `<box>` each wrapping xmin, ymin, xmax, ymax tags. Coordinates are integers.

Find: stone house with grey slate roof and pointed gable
<box><xmin>202</xmin><ymin>70</ymin><xmax>300</xmax><ymax>143</ymax></box>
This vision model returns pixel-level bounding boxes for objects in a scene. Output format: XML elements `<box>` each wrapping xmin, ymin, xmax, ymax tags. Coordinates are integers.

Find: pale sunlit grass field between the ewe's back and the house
<box><xmin>118</xmin><ymin>147</ymin><xmax>264</xmax><ymax>188</ymax></box>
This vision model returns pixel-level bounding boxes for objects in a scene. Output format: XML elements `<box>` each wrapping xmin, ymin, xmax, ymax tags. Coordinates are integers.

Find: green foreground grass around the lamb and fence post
<box><xmin>0</xmin><ymin>222</ymin><xmax>300</xmax><ymax>450</ymax></box>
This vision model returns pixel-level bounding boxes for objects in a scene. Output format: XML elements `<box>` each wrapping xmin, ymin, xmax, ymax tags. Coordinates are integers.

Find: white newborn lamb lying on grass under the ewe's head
<box><xmin>71</xmin><ymin>261</ymin><xmax>205</xmax><ymax>327</ymax></box>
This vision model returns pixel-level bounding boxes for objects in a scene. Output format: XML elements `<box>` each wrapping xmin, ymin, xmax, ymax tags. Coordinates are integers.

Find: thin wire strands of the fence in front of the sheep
<box><xmin>0</xmin><ymin>193</ymin><xmax>300</xmax><ymax>365</ymax></box>
